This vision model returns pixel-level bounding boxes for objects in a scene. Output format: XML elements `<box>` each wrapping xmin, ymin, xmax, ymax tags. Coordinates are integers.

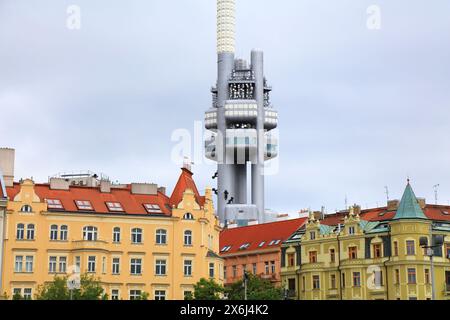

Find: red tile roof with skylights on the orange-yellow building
<box><xmin>3</xmin><ymin>169</ymin><xmax>205</xmax><ymax>216</ymax></box>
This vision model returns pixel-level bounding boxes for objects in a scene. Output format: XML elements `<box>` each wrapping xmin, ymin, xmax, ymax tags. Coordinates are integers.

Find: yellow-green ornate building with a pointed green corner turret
<box><xmin>281</xmin><ymin>183</ymin><xmax>450</xmax><ymax>300</ymax></box>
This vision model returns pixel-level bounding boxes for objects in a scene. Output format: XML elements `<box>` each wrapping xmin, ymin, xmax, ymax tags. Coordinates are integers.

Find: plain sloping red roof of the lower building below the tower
<box><xmin>220</xmin><ymin>218</ymin><xmax>307</xmax><ymax>256</ymax></box>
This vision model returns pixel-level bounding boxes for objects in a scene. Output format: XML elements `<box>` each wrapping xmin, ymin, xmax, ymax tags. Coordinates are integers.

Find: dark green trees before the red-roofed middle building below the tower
<box><xmin>227</xmin><ymin>274</ymin><xmax>283</xmax><ymax>300</ymax></box>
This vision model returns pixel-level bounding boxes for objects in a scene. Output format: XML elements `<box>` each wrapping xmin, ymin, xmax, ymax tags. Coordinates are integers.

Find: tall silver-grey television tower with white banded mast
<box><xmin>205</xmin><ymin>0</ymin><xmax>278</xmax><ymax>225</ymax></box>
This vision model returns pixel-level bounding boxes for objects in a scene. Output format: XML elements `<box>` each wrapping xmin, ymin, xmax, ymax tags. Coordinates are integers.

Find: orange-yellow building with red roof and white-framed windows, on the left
<box><xmin>0</xmin><ymin>150</ymin><xmax>223</xmax><ymax>300</ymax></box>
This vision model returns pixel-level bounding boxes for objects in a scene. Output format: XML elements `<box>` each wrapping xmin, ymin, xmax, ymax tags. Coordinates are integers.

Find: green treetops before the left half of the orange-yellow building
<box><xmin>36</xmin><ymin>274</ymin><xmax>107</xmax><ymax>300</ymax></box>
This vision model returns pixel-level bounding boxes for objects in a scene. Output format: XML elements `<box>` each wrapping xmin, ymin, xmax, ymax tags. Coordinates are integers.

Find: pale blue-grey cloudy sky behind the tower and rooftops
<box><xmin>0</xmin><ymin>0</ymin><xmax>450</xmax><ymax>213</ymax></box>
